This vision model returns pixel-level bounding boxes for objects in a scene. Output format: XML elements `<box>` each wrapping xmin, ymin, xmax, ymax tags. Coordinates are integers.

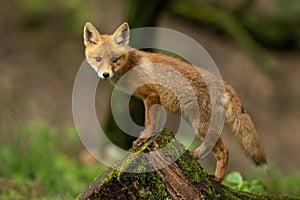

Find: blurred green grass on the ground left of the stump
<box><xmin>0</xmin><ymin>119</ymin><xmax>104</xmax><ymax>200</ymax></box>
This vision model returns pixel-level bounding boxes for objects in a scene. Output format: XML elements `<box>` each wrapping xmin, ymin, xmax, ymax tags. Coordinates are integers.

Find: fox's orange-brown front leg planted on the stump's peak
<box><xmin>133</xmin><ymin>94</ymin><xmax>163</xmax><ymax>149</ymax></box>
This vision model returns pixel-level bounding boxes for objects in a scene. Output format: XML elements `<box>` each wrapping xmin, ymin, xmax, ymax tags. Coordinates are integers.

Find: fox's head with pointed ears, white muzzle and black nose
<box><xmin>83</xmin><ymin>22</ymin><xmax>129</xmax><ymax>79</ymax></box>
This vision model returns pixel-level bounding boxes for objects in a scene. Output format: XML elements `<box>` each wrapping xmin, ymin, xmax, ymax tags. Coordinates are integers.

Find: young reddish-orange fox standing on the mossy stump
<box><xmin>83</xmin><ymin>22</ymin><xmax>266</xmax><ymax>182</ymax></box>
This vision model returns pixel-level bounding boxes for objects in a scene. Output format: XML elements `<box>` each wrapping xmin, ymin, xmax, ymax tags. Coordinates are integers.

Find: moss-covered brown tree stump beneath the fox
<box><xmin>78</xmin><ymin>129</ymin><xmax>292</xmax><ymax>200</ymax></box>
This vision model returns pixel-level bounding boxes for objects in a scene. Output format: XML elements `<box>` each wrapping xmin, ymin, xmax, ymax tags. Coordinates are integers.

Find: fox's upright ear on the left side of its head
<box><xmin>83</xmin><ymin>22</ymin><xmax>100</xmax><ymax>46</ymax></box>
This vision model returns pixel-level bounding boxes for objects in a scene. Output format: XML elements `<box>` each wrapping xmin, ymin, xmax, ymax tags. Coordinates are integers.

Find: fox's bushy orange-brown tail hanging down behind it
<box><xmin>226</xmin><ymin>88</ymin><xmax>267</xmax><ymax>166</ymax></box>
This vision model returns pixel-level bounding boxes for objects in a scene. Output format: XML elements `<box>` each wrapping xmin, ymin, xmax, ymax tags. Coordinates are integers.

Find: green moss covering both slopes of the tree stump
<box><xmin>78</xmin><ymin>129</ymin><xmax>295</xmax><ymax>200</ymax></box>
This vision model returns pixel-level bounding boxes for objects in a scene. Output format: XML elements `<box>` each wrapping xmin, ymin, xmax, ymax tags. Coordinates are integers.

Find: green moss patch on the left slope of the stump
<box><xmin>87</xmin><ymin>131</ymin><xmax>173</xmax><ymax>199</ymax></box>
